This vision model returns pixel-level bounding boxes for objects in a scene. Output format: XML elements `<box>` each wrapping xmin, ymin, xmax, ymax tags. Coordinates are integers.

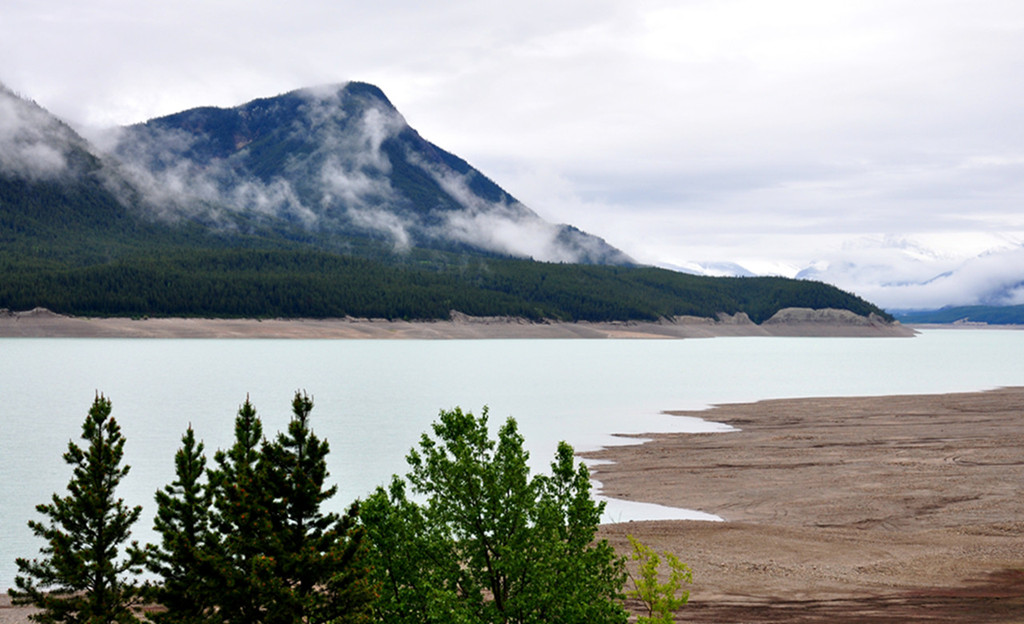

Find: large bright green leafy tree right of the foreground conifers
<box><xmin>362</xmin><ymin>408</ymin><xmax>626</xmax><ymax>624</ymax></box>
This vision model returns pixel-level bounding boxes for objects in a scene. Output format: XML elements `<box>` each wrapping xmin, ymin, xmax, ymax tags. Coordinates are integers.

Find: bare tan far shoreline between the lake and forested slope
<box><xmin>0</xmin><ymin>308</ymin><xmax>916</xmax><ymax>340</ymax></box>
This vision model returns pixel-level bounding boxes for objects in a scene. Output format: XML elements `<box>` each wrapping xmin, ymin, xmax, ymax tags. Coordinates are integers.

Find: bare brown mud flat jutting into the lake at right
<box><xmin>585</xmin><ymin>388</ymin><xmax>1024</xmax><ymax>624</ymax></box>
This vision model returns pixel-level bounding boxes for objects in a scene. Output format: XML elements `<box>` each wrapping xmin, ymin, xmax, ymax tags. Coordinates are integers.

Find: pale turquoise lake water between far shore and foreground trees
<box><xmin>0</xmin><ymin>330</ymin><xmax>1024</xmax><ymax>587</ymax></box>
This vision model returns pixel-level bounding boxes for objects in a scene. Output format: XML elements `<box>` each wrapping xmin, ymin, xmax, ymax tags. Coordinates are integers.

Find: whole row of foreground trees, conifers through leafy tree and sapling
<box><xmin>10</xmin><ymin>392</ymin><xmax>690</xmax><ymax>624</ymax></box>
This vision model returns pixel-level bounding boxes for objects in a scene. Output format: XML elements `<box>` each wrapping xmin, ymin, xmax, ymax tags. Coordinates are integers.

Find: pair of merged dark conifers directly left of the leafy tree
<box><xmin>191</xmin><ymin>393</ymin><xmax>375</xmax><ymax>624</ymax></box>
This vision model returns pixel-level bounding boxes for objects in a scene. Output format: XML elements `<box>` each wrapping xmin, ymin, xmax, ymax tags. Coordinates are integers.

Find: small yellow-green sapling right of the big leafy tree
<box><xmin>626</xmin><ymin>535</ymin><xmax>693</xmax><ymax>624</ymax></box>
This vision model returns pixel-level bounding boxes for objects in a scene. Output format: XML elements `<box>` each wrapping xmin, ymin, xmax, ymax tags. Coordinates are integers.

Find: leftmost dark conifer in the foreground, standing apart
<box><xmin>10</xmin><ymin>394</ymin><xmax>144</xmax><ymax>624</ymax></box>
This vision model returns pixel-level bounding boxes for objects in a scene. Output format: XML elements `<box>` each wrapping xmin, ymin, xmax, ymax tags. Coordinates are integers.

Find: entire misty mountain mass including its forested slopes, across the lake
<box><xmin>0</xmin><ymin>83</ymin><xmax>891</xmax><ymax>323</ymax></box>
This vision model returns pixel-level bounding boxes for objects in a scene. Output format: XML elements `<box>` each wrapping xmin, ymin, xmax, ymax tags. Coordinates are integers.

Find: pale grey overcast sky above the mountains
<box><xmin>0</xmin><ymin>0</ymin><xmax>1024</xmax><ymax>307</ymax></box>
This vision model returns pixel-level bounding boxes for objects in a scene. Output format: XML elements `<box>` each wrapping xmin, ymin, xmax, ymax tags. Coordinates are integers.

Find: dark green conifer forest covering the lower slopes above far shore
<box><xmin>0</xmin><ymin>173</ymin><xmax>888</xmax><ymax>323</ymax></box>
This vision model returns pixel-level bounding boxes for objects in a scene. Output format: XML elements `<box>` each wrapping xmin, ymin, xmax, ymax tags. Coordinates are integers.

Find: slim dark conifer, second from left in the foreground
<box><xmin>146</xmin><ymin>426</ymin><xmax>217</xmax><ymax>624</ymax></box>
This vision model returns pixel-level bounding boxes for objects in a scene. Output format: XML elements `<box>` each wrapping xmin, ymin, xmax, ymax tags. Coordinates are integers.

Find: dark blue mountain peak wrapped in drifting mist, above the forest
<box><xmin>112</xmin><ymin>82</ymin><xmax>631</xmax><ymax>264</ymax></box>
